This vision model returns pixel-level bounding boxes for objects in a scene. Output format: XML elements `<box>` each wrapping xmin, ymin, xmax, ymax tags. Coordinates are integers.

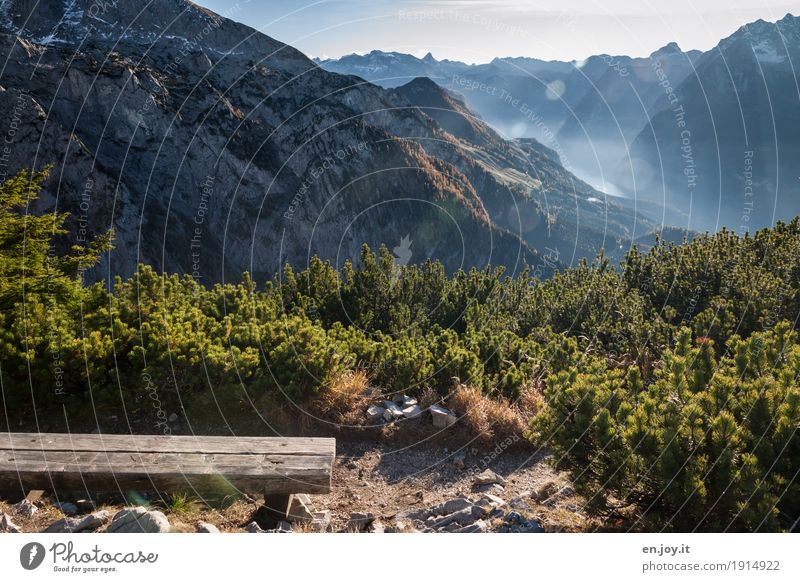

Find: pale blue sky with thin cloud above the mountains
<box><xmin>196</xmin><ymin>0</ymin><xmax>800</xmax><ymax>62</ymax></box>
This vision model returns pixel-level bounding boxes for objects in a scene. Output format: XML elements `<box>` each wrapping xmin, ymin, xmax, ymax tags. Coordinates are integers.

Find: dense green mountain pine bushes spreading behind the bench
<box><xmin>0</xmin><ymin>171</ymin><xmax>800</xmax><ymax>531</ymax></box>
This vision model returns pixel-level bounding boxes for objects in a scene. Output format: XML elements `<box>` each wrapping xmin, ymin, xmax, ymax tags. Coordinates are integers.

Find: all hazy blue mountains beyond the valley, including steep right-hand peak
<box><xmin>318</xmin><ymin>14</ymin><xmax>800</xmax><ymax>232</ymax></box>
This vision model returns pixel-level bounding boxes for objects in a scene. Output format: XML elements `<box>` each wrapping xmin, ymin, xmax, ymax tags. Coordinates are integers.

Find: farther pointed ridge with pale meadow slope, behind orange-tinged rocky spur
<box><xmin>394</xmin><ymin>78</ymin><xmax>654</xmax><ymax>263</ymax></box>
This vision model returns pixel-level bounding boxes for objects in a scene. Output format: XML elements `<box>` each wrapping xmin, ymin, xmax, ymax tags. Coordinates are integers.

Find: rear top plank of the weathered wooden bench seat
<box><xmin>0</xmin><ymin>433</ymin><xmax>336</xmax><ymax>455</ymax></box>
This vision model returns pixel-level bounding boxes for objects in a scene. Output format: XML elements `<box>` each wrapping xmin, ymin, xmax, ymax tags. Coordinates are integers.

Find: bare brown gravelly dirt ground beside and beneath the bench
<box><xmin>0</xmin><ymin>439</ymin><xmax>598</xmax><ymax>532</ymax></box>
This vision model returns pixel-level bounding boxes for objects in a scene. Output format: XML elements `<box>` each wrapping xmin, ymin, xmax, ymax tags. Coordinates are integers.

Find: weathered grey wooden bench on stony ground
<box><xmin>0</xmin><ymin>433</ymin><xmax>336</xmax><ymax>511</ymax></box>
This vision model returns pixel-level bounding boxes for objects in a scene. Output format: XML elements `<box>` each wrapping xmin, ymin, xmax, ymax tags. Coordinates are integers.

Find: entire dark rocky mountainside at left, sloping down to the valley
<box><xmin>0</xmin><ymin>0</ymin><xmax>654</xmax><ymax>283</ymax></box>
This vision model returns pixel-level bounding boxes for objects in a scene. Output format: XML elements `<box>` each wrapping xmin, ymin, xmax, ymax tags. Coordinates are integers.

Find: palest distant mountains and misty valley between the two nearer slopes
<box><xmin>320</xmin><ymin>43</ymin><xmax>701</xmax><ymax>208</ymax></box>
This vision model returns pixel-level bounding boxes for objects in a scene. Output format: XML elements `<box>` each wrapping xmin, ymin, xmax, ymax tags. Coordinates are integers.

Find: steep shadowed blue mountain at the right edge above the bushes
<box><xmin>622</xmin><ymin>15</ymin><xmax>800</xmax><ymax>231</ymax></box>
